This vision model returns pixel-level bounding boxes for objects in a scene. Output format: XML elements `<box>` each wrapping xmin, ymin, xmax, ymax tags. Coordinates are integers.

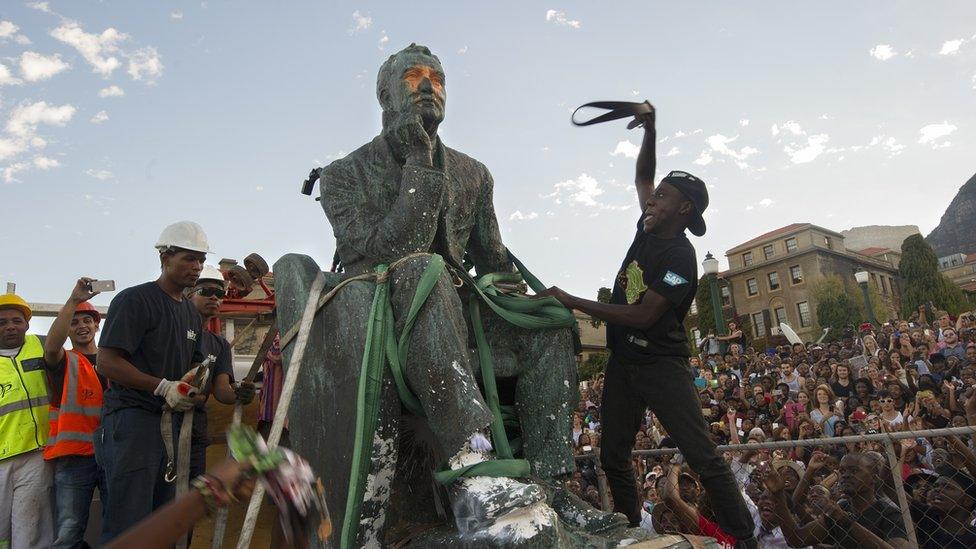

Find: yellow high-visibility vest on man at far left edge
<box><xmin>0</xmin><ymin>334</ymin><xmax>50</xmax><ymax>460</ymax></box>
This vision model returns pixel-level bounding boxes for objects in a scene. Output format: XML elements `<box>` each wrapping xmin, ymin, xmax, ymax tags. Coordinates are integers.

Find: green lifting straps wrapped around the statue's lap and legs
<box><xmin>340</xmin><ymin>252</ymin><xmax>579</xmax><ymax>549</ymax></box>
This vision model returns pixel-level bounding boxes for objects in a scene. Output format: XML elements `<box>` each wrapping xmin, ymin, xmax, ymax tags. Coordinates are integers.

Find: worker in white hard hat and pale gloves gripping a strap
<box><xmin>95</xmin><ymin>221</ymin><xmax>210</xmax><ymax>543</ymax></box>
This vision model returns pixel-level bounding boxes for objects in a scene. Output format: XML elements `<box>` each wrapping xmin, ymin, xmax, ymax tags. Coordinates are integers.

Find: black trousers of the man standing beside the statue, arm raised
<box><xmin>600</xmin><ymin>355</ymin><xmax>754</xmax><ymax>539</ymax></box>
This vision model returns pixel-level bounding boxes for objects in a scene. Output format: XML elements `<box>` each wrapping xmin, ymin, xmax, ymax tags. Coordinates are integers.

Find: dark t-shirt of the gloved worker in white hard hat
<box><xmin>98</xmin><ymin>282</ymin><xmax>203</xmax><ymax>415</ymax></box>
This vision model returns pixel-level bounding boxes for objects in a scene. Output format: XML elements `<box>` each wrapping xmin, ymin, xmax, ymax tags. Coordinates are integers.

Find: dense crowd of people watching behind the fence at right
<box><xmin>571</xmin><ymin>306</ymin><xmax>976</xmax><ymax>547</ymax></box>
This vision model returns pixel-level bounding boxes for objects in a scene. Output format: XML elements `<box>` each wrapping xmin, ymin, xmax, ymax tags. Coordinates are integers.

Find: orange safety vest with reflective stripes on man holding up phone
<box><xmin>44</xmin><ymin>351</ymin><xmax>102</xmax><ymax>459</ymax></box>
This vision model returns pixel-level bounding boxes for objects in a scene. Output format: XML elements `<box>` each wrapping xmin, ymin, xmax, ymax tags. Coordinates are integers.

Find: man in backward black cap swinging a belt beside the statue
<box><xmin>545</xmin><ymin>105</ymin><xmax>756</xmax><ymax>547</ymax></box>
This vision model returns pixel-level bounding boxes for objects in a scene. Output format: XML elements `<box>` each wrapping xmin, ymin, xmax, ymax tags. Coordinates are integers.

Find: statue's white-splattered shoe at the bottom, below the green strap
<box><xmin>450</xmin><ymin>476</ymin><xmax>546</xmax><ymax>535</ymax></box>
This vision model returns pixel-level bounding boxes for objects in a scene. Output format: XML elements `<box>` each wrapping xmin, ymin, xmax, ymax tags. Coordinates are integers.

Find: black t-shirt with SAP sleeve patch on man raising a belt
<box><xmin>607</xmin><ymin>215</ymin><xmax>698</xmax><ymax>364</ymax></box>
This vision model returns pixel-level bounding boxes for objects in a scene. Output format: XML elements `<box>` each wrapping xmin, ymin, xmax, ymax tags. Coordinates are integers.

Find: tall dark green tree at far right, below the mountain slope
<box><xmin>898</xmin><ymin>234</ymin><xmax>967</xmax><ymax>318</ymax></box>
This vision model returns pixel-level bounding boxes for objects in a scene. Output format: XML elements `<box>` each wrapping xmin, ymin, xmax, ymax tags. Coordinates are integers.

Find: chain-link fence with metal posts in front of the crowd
<box><xmin>576</xmin><ymin>426</ymin><xmax>976</xmax><ymax>548</ymax></box>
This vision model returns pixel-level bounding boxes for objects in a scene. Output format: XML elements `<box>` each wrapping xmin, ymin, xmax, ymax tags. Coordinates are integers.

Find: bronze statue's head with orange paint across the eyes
<box><xmin>376</xmin><ymin>44</ymin><xmax>447</xmax><ymax>128</ymax></box>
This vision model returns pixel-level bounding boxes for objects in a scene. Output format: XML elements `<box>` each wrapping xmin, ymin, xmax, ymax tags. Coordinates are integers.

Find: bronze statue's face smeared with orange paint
<box><xmin>389</xmin><ymin>57</ymin><xmax>447</xmax><ymax>123</ymax></box>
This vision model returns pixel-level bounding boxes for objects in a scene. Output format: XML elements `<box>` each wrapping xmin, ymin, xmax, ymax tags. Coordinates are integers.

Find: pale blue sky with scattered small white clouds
<box><xmin>0</xmin><ymin>0</ymin><xmax>976</xmax><ymax>330</ymax></box>
